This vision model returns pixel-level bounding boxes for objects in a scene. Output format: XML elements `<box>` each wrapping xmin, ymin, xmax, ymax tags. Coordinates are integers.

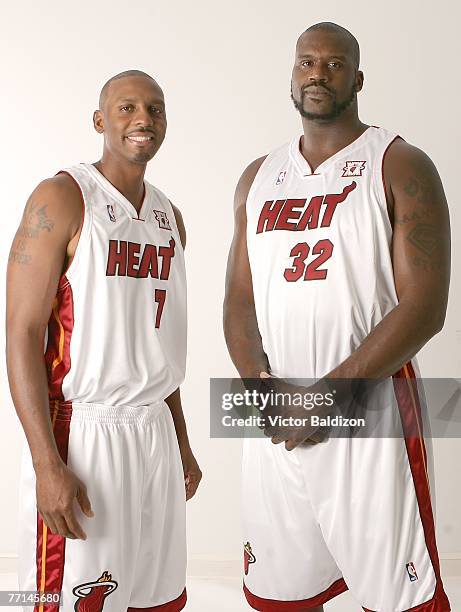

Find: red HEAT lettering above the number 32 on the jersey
<box><xmin>256</xmin><ymin>181</ymin><xmax>357</xmax><ymax>234</ymax></box>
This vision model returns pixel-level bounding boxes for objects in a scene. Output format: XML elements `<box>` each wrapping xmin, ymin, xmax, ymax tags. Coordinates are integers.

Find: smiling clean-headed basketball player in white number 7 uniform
<box><xmin>7</xmin><ymin>70</ymin><xmax>201</xmax><ymax>612</ymax></box>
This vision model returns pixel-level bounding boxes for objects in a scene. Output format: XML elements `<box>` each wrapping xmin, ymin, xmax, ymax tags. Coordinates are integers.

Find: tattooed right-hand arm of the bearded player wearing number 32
<box><xmin>326</xmin><ymin>139</ymin><xmax>450</xmax><ymax>378</ymax></box>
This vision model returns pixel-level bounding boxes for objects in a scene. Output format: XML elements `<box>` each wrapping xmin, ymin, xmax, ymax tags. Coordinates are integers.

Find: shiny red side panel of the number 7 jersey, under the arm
<box><xmin>45</xmin><ymin>276</ymin><xmax>74</xmax><ymax>401</ymax></box>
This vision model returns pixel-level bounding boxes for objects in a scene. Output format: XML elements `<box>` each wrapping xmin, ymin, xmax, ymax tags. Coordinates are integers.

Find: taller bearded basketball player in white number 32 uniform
<box><xmin>225</xmin><ymin>23</ymin><xmax>450</xmax><ymax>612</ymax></box>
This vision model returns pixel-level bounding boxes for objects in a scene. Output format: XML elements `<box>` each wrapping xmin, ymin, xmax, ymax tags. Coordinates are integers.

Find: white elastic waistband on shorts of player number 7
<box><xmin>50</xmin><ymin>400</ymin><xmax>168</xmax><ymax>424</ymax></box>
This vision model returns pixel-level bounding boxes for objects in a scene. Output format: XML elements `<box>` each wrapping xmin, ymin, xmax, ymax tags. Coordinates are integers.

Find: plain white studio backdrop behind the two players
<box><xmin>0</xmin><ymin>0</ymin><xmax>461</xmax><ymax>572</ymax></box>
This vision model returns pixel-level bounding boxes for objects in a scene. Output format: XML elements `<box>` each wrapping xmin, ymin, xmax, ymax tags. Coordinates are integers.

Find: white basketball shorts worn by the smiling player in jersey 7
<box><xmin>19</xmin><ymin>402</ymin><xmax>186</xmax><ymax>612</ymax></box>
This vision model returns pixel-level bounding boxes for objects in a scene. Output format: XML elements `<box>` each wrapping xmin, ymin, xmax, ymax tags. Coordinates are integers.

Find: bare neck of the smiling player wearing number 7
<box><xmin>93</xmin><ymin>152</ymin><xmax>146</xmax><ymax>213</ymax></box>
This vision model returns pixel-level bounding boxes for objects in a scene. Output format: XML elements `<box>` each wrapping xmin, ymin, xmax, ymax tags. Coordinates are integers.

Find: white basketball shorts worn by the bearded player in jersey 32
<box><xmin>243</xmin><ymin>366</ymin><xmax>450</xmax><ymax>612</ymax></box>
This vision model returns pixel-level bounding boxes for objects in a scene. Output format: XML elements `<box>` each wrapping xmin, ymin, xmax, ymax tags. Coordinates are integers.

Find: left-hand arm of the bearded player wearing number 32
<box><xmin>224</xmin><ymin>157</ymin><xmax>270</xmax><ymax>378</ymax></box>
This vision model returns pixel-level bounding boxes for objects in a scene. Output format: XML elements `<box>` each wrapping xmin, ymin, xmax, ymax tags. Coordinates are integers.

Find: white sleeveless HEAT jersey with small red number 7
<box><xmin>45</xmin><ymin>164</ymin><xmax>186</xmax><ymax>406</ymax></box>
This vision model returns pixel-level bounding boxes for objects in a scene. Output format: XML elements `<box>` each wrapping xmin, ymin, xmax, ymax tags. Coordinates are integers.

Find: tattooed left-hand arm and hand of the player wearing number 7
<box><xmin>6</xmin><ymin>175</ymin><xmax>91</xmax><ymax>538</ymax></box>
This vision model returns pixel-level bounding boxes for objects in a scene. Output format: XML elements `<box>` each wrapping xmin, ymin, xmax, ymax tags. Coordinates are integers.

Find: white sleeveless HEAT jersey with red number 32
<box><xmin>246</xmin><ymin>127</ymin><xmax>397</xmax><ymax>378</ymax></box>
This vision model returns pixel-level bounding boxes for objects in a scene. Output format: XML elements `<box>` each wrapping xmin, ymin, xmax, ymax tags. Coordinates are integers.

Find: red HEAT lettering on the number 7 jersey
<box><xmin>106</xmin><ymin>238</ymin><xmax>176</xmax><ymax>280</ymax></box>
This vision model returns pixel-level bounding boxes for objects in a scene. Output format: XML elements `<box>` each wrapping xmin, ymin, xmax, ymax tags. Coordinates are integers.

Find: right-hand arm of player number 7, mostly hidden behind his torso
<box><xmin>165</xmin><ymin>204</ymin><xmax>202</xmax><ymax>499</ymax></box>
